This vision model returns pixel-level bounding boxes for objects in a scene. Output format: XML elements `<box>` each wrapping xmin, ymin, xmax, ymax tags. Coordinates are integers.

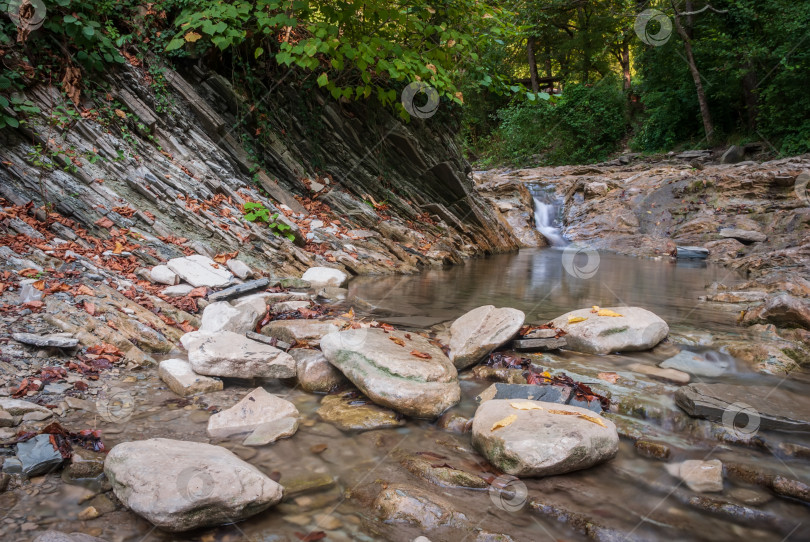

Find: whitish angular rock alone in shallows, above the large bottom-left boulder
<box><xmin>208</xmin><ymin>388</ymin><xmax>300</xmax><ymax>438</ymax></box>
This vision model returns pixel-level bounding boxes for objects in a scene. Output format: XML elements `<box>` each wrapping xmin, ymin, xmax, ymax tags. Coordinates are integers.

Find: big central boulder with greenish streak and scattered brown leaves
<box><xmin>321</xmin><ymin>328</ymin><xmax>461</xmax><ymax>418</ymax></box>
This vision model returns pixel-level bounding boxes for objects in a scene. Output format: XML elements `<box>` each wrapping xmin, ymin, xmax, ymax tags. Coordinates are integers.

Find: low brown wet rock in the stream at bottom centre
<box><xmin>373</xmin><ymin>484</ymin><xmax>467</xmax><ymax>530</ymax></box>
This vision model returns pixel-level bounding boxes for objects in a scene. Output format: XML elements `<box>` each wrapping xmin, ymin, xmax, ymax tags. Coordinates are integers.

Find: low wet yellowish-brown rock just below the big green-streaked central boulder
<box><xmin>316</xmin><ymin>394</ymin><xmax>405</xmax><ymax>431</ymax></box>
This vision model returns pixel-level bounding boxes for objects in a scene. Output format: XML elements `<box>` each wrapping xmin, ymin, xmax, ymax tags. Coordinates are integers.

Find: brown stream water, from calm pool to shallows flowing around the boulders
<box><xmin>6</xmin><ymin>249</ymin><xmax>810</xmax><ymax>542</ymax></box>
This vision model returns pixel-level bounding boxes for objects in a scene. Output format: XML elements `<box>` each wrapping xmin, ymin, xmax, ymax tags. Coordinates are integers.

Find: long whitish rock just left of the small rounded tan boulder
<box><xmin>181</xmin><ymin>331</ymin><xmax>295</xmax><ymax>378</ymax></box>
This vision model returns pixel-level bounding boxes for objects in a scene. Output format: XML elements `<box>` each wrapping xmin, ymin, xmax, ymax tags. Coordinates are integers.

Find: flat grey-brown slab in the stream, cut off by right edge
<box><xmin>675</xmin><ymin>383</ymin><xmax>810</xmax><ymax>434</ymax></box>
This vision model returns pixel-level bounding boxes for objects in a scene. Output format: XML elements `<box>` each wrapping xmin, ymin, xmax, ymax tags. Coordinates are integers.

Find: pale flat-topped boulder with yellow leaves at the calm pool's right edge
<box><xmin>551</xmin><ymin>307</ymin><xmax>669</xmax><ymax>354</ymax></box>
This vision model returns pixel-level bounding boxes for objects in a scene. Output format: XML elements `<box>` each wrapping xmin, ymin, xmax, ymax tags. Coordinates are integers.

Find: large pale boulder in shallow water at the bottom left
<box><xmin>104</xmin><ymin>438</ymin><xmax>282</xmax><ymax>531</ymax></box>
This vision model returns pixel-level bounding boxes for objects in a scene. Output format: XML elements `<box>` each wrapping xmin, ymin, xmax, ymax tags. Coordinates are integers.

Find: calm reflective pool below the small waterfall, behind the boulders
<box><xmin>349</xmin><ymin>249</ymin><xmax>741</xmax><ymax>329</ymax></box>
